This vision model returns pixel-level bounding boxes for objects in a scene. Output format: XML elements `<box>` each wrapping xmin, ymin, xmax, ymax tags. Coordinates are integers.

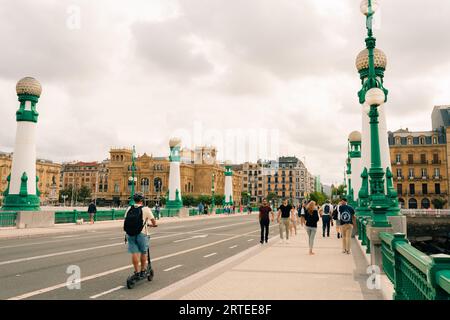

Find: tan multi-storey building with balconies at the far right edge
<box><xmin>388</xmin><ymin>106</ymin><xmax>450</xmax><ymax>209</ymax></box>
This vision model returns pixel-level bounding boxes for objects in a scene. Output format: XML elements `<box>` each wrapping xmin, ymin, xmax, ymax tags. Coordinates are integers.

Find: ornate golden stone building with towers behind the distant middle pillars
<box><xmin>99</xmin><ymin>147</ymin><xmax>242</xmax><ymax>206</ymax></box>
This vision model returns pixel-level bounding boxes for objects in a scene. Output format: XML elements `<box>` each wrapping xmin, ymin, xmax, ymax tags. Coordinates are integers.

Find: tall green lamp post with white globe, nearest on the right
<box><xmin>358</xmin><ymin>0</ymin><xmax>391</xmax><ymax>228</ymax></box>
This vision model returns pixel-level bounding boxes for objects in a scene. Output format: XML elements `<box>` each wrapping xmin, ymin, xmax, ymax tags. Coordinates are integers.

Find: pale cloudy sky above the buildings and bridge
<box><xmin>0</xmin><ymin>0</ymin><xmax>450</xmax><ymax>183</ymax></box>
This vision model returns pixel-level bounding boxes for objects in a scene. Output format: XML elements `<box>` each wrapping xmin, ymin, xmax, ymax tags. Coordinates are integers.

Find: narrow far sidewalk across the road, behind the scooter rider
<box><xmin>0</xmin><ymin>213</ymin><xmax>257</xmax><ymax>240</ymax></box>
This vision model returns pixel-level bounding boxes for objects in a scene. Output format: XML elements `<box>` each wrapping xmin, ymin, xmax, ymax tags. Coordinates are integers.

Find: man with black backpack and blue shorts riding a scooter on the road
<box><xmin>123</xmin><ymin>193</ymin><xmax>157</xmax><ymax>279</ymax></box>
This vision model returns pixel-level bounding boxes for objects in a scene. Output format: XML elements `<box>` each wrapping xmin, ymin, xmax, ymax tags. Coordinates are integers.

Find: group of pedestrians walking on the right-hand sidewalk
<box><xmin>259</xmin><ymin>198</ymin><xmax>355</xmax><ymax>255</ymax></box>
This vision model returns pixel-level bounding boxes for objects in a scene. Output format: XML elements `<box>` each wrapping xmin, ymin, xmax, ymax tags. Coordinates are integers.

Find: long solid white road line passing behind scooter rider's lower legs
<box><xmin>7</xmin><ymin>234</ymin><xmax>246</xmax><ymax>300</ymax></box>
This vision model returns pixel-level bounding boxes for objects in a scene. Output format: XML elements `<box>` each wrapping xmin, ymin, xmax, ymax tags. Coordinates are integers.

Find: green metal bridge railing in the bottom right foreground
<box><xmin>380</xmin><ymin>232</ymin><xmax>450</xmax><ymax>300</ymax></box>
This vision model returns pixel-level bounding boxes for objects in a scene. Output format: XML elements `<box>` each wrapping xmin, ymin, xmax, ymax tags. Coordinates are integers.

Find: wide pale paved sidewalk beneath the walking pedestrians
<box><xmin>144</xmin><ymin>225</ymin><xmax>383</xmax><ymax>300</ymax></box>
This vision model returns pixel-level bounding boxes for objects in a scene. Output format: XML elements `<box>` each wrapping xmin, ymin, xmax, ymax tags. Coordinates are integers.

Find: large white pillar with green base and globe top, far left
<box><xmin>2</xmin><ymin>77</ymin><xmax>42</xmax><ymax>211</ymax></box>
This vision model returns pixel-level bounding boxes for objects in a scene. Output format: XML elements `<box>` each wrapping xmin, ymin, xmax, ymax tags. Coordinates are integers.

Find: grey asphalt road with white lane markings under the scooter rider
<box><xmin>0</xmin><ymin>215</ymin><xmax>278</xmax><ymax>300</ymax></box>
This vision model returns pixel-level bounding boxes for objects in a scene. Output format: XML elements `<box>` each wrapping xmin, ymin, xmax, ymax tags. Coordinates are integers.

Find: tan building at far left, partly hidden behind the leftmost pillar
<box><xmin>0</xmin><ymin>152</ymin><xmax>61</xmax><ymax>205</ymax></box>
